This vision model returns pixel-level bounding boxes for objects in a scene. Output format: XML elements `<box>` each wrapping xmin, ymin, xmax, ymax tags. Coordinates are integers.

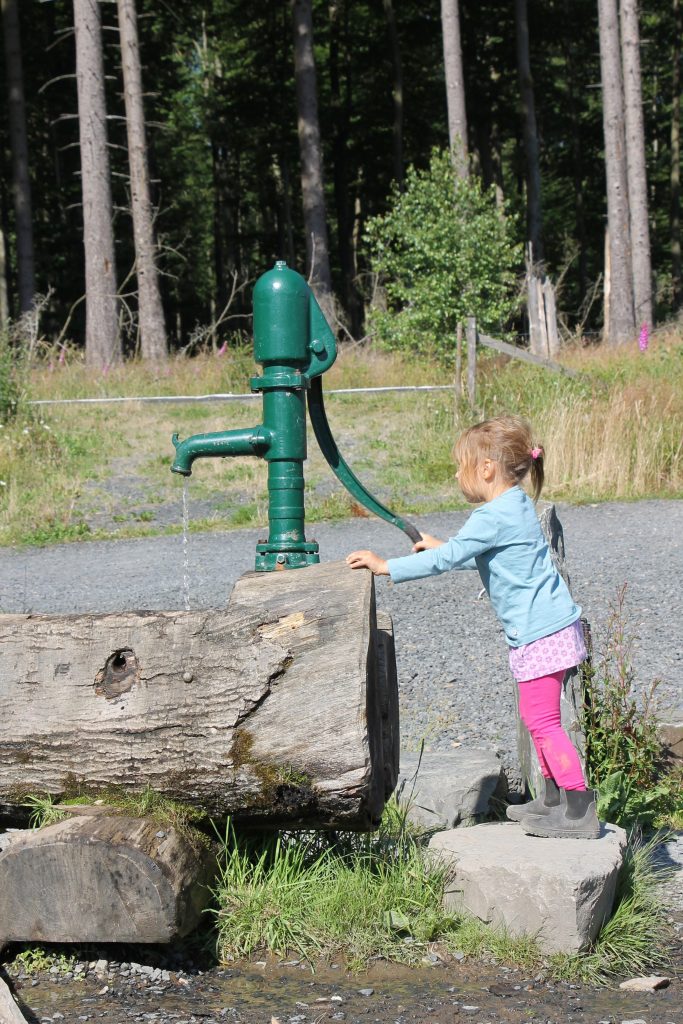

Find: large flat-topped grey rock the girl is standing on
<box><xmin>429</xmin><ymin>822</ymin><xmax>626</xmax><ymax>953</ymax></box>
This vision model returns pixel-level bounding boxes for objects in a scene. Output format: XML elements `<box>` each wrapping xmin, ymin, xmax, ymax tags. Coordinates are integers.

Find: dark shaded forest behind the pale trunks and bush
<box><xmin>0</xmin><ymin>0</ymin><xmax>682</xmax><ymax>353</ymax></box>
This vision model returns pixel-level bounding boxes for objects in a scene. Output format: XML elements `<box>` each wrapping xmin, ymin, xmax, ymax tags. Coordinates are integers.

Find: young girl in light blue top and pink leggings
<box><xmin>346</xmin><ymin>416</ymin><xmax>600</xmax><ymax>839</ymax></box>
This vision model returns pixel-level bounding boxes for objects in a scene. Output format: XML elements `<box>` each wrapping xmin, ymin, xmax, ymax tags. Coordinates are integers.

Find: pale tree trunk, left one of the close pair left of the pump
<box><xmin>74</xmin><ymin>0</ymin><xmax>122</xmax><ymax>368</ymax></box>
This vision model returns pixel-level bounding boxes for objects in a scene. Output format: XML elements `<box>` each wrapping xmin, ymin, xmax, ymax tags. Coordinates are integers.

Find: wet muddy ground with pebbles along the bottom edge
<box><xmin>3</xmin><ymin>947</ymin><xmax>683</xmax><ymax>1024</ymax></box>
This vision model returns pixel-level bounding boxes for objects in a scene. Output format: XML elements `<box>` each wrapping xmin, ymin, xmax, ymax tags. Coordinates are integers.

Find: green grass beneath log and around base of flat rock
<box><xmin>215</xmin><ymin>802</ymin><xmax>668</xmax><ymax>982</ymax></box>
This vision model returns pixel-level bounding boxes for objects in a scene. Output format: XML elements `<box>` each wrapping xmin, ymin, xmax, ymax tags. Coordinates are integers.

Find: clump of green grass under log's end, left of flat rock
<box><xmin>210</xmin><ymin>805</ymin><xmax>456</xmax><ymax>968</ymax></box>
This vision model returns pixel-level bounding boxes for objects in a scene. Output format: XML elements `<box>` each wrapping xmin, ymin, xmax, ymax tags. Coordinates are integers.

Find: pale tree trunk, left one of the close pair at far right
<box><xmin>598</xmin><ymin>0</ymin><xmax>635</xmax><ymax>345</ymax></box>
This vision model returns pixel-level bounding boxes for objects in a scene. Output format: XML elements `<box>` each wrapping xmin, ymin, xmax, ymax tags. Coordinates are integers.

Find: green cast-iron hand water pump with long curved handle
<box><xmin>171</xmin><ymin>261</ymin><xmax>420</xmax><ymax>571</ymax></box>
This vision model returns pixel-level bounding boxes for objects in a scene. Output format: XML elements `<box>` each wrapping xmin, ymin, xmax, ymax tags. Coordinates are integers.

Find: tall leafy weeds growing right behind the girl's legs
<box><xmin>584</xmin><ymin>585</ymin><xmax>681</xmax><ymax>825</ymax></box>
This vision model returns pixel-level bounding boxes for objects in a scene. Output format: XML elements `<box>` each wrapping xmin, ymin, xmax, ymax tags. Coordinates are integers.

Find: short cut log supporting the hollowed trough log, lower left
<box><xmin>0</xmin><ymin>814</ymin><xmax>215</xmax><ymax>942</ymax></box>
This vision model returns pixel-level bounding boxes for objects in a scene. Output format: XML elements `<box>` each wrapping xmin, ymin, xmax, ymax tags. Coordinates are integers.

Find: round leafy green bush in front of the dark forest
<box><xmin>367</xmin><ymin>150</ymin><xmax>521</xmax><ymax>355</ymax></box>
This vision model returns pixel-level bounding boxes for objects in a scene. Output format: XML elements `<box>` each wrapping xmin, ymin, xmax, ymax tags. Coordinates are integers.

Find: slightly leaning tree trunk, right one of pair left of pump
<box><xmin>118</xmin><ymin>0</ymin><xmax>168</xmax><ymax>361</ymax></box>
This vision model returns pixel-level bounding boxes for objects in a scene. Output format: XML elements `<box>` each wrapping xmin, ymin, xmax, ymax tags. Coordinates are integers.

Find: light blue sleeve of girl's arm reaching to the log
<box><xmin>387</xmin><ymin>506</ymin><xmax>498</xmax><ymax>583</ymax></box>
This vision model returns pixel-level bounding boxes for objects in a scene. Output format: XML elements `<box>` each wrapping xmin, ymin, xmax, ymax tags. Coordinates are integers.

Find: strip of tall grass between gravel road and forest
<box><xmin>0</xmin><ymin>333</ymin><xmax>683</xmax><ymax>544</ymax></box>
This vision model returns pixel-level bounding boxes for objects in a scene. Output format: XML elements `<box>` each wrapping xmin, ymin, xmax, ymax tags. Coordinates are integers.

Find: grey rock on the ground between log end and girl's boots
<box><xmin>397</xmin><ymin>748</ymin><xmax>503</xmax><ymax>830</ymax></box>
